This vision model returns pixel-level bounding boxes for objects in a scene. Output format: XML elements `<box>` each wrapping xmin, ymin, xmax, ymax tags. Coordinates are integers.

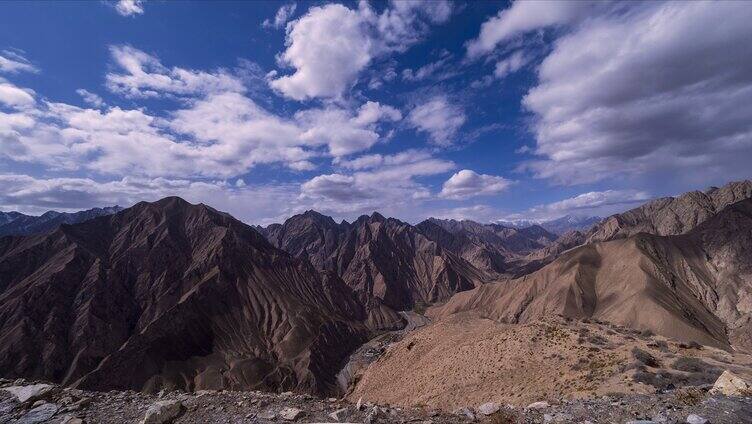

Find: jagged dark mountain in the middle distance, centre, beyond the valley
<box><xmin>264</xmin><ymin>211</ymin><xmax>489</xmax><ymax>310</ymax></box>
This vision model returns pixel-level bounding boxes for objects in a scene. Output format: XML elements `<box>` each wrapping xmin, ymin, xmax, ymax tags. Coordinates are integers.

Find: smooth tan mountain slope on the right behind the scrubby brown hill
<box><xmin>431</xmin><ymin>199</ymin><xmax>752</xmax><ymax>349</ymax></box>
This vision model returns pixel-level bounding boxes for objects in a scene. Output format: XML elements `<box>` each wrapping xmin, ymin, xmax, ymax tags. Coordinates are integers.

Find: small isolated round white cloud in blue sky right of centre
<box><xmin>407</xmin><ymin>96</ymin><xmax>467</xmax><ymax>146</ymax></box>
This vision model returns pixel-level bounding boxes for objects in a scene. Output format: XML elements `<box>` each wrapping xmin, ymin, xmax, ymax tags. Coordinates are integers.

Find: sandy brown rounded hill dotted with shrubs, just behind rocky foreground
<box><xmin>349</xmin><ymin>313</ymin><xmax>752</xmax><ymax>411</ymax></box>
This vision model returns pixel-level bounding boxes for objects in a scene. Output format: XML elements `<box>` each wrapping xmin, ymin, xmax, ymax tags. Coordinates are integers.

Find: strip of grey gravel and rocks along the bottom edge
<box><xmin>0</xmin><ymin>376</ymin><xmax>752</xmax><ymax>424</ymax></box>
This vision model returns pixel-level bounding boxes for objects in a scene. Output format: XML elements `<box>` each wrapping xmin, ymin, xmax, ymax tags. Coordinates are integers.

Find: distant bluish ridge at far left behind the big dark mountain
<box><xmin>0</xmin><ymin>206</ymin><xmax>123</xmax><ymax>237</ymax></box>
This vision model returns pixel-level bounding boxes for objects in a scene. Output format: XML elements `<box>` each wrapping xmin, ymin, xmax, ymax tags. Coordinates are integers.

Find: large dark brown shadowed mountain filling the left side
<box><xmin>0</xmin><ymin>198</ymin><xmax>378</xmax><ymax>393</ymax></box>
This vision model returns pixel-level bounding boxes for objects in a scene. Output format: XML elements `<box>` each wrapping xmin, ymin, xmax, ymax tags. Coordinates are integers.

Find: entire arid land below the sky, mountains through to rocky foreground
<box><xmin>0</xmin><ymin>182</ymin><xmax>752</xmax><ymax>424</ymax></box>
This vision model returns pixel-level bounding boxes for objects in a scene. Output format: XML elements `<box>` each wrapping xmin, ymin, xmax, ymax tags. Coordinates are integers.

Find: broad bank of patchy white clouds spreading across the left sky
<box><xmin>0</xmin><ymin>48</ymin><xmax>402</xmax><ymax>178</ymax></box>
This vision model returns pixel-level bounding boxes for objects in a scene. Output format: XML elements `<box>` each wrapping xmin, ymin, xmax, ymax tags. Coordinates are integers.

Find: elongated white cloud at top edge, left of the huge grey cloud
<box><xmin>466</xmin><ymin>0</ymin><xmax>608</xmax><ymax>59</ymax></box>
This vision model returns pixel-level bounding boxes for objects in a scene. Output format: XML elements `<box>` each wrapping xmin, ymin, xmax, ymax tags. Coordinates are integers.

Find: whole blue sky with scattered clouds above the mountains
<box><xmin>0</xmin><ymin>0</ymin><xmax>752</xmax><ymax>225</ymax></box>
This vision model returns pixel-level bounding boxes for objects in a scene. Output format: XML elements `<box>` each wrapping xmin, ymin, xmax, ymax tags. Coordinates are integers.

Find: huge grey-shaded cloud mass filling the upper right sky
<box><xmin>515</xmin><ymin>2</ymin><xmax>752</xmax><ymax>184</ymax></box>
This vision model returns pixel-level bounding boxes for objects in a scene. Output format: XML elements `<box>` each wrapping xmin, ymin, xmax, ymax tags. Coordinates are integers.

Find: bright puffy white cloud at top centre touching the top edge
<box><xmin>270</xmin><ymin>1</ymin><xmax>452</xmax><ymax>100</ymax></box>
